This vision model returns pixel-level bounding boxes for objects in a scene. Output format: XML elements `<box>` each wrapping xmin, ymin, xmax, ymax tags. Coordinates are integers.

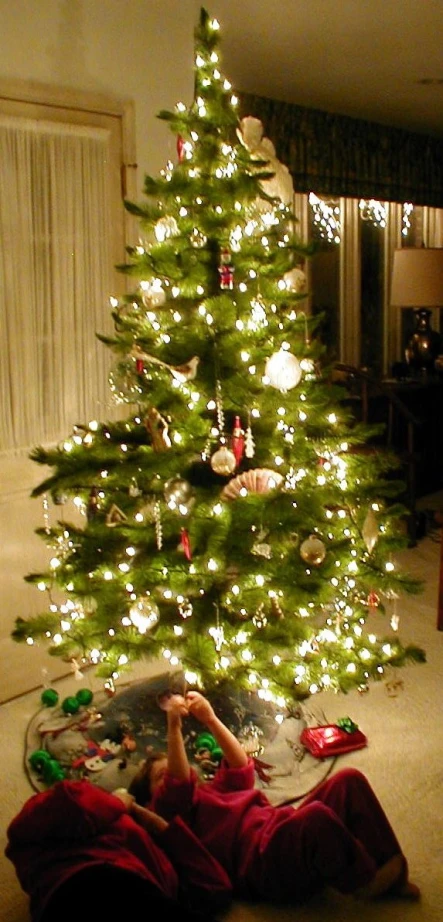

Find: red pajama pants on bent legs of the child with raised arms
<box><xmin>242</xmin><ymin>768</ymin><xmax>401</xmax><ymax>902</ymax></box>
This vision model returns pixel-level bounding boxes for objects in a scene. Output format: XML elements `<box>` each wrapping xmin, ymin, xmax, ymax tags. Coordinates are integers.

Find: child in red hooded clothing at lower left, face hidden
<box><xmin>5</xmin><ymin>780</ymin><xmax>232</xmax><ymax>922</ymax></box>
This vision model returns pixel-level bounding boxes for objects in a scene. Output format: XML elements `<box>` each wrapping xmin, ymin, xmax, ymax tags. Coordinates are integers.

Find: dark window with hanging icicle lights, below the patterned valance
<box><xmin>304</xmin><ymin>193</ymin><xmax>443</xmax><ymax>377</ymax></box>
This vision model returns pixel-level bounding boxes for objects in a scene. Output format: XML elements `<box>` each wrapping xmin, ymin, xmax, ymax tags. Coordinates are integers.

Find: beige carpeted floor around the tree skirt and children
<box><xmin>0</xmin><ymin>510</ymin><xmax>443</xmax><ymax>922</ymax></box>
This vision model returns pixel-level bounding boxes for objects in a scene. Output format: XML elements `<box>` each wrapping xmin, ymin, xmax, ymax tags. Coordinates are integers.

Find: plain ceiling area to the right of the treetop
<box><xmin>199</xmin><ymin>0</ymin><xmax>443</xmax><ymax>137</ymax></box>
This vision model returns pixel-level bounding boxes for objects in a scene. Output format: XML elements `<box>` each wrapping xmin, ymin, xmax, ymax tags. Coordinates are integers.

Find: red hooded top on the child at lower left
<box><xmin>5</xmin><ymin>780</ymin><xmax>232</xmax><ymax>922</ymax></box>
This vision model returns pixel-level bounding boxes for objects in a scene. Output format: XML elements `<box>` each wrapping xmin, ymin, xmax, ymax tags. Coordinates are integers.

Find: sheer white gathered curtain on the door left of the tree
<box><xmin>0</xmin><ymin>116</ymin><xmax>113</xmax><ymax>455</ymax></box>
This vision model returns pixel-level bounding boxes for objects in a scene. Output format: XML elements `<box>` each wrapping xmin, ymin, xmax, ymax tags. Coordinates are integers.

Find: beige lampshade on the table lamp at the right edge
<box><xmin>391</xmin><ymin>247</ymin><xmax>443</xmax><ymax>307</ymax></box>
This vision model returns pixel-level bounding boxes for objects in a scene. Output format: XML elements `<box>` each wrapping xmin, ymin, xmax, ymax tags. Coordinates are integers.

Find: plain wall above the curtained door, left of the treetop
<box><xmin>0</xmin><ymin>0</ymin><xmax>200</xmax><ymax>188</ymax></box>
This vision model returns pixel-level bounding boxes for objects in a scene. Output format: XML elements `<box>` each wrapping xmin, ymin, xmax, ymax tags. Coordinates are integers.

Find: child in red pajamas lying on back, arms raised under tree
<box><xmin>129</xmin><ymin>691</ymin><xmax>420</xmax><ymax>904</ymax></box>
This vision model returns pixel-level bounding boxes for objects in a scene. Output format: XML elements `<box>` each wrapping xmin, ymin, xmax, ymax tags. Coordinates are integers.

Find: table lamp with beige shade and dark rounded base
<box><xmin>391</xmin><ymin>247</ymin><xmax>443</xmax><ymax>374</ymax></box>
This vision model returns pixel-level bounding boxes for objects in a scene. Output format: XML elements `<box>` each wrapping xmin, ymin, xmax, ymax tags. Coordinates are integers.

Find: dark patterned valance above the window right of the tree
<box><xmin>240</xmin><ymin>93</ymin><xmax>443</xmax><ymax>208</ymax></box>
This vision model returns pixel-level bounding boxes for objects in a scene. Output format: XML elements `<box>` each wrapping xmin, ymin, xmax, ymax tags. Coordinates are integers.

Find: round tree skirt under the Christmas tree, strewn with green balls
<box><xmin>25</xmin><ymin>673</ymin><xmax>342</xmax><ymax>804</ymax></box>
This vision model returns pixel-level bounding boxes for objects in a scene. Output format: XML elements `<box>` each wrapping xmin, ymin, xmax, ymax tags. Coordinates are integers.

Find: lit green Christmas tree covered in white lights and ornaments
<box><xmin>13</xmin><ymin>10</ymin><xmax>424</xmax><ymax>705</ymax></box>
